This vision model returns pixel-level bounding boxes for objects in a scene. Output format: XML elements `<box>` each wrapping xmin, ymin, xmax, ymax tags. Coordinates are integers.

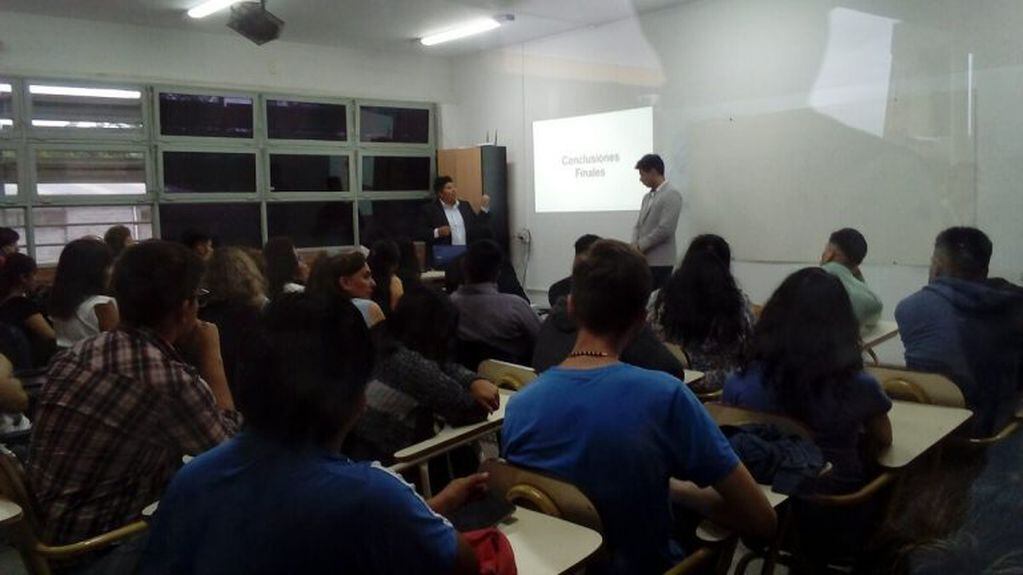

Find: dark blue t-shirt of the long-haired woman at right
<box><xmin>721</xmin><ymin>365</ymin><xmax>892</xmax><ymax>485</ymax></box>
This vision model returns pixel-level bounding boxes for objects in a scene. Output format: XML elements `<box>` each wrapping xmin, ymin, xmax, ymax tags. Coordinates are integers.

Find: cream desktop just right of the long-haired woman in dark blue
<box><xmin>878</xmin><ymin>401</ymin><xmax>973</xmax><ymax>469</ymax></box>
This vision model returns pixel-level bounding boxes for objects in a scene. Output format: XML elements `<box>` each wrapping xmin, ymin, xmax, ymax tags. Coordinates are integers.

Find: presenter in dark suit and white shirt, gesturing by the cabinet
<box><xmin>419</xmin><ymin>176</ymin><xmax>491</xmax><ymax>254</ymax></box>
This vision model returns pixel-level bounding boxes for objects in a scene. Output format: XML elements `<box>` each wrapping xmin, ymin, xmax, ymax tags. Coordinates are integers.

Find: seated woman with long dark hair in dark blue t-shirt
<box><xmin>722</xmin><ymin>268</ymin><xmax>892</xmax><ymax>491</ymax></box>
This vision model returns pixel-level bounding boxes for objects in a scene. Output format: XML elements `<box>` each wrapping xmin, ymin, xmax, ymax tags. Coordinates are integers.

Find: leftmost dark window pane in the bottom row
<box><xmin>160</xmin><ymin>204</ymin><xmax>263</xmax><ymax>248</ymax></box>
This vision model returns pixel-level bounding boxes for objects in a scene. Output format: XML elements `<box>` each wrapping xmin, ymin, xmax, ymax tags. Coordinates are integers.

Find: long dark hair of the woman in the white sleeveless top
<box><xmin>50</xmin><ymin>237</ymin><xmax>114</xmax><ymax>319</ymax></box>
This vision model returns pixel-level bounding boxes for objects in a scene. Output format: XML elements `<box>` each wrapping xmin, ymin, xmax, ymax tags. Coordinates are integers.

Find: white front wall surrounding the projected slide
<box><xmin>441</xmin><ymin>0</ymin><xmax>1023</xmax><ymax>359</ymax></box>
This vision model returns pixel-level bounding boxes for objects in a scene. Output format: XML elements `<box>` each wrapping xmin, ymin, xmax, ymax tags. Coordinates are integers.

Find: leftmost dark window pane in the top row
<box><xmin>160</xmin><ymin>92</ymin><xmax>253</xmax><ymax>138</ymax></box>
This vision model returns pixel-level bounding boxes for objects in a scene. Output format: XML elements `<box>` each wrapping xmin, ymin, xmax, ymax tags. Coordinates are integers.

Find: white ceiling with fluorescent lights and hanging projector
<box><xmin>0</xmin><ymin>0</ymin><xmax>692</xmax><ymax>55</ymax></box>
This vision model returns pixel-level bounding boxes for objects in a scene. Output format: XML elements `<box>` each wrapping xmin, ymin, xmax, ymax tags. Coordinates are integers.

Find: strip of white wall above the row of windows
<box><xmin>0</xmin><ymin>12</ymin><xmax>451</xmax><ymax>102</ymax></box>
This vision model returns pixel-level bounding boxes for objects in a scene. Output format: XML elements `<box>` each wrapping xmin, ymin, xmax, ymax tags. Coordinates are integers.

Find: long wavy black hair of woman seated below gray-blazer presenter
<box><xmin>654</xmin><ymin>234</ymin><xmax>746</xmax><ymax>348</ymax></box>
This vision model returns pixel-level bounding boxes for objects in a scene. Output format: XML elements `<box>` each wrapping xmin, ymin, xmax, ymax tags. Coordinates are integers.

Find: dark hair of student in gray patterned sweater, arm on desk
<box><xmin>383</xmin><ymin>285</ymin><xmax>458</xmax><ymax>362</ymax></box>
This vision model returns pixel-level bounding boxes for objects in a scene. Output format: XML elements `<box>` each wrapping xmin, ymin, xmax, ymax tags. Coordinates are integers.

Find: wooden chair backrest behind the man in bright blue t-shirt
<box><xmin>480</xmin><ymin>459</ymin><xmax>604</xmax><ymax>533</ymax></box>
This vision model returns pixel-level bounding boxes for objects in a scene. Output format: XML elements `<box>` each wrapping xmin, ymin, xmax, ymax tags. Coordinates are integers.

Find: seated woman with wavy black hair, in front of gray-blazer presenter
<box><xmin>653</xmin><ymin>234</ymin><xmax>753</xmax><ymax>392</ymax></box>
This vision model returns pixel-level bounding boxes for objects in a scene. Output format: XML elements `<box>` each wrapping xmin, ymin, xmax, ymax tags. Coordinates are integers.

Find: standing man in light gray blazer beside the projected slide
<box><xmin>632</xmin><ymin>153</ymin><xmax>682</xmax><ymax>290</ymax></box>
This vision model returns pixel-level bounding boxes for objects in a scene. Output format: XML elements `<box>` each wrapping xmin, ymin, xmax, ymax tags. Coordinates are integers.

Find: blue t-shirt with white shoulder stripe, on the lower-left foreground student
<box><xmin>139</xmin><ymin>432</ymin><xmax>457</xmax><ymax>575</ymax></box>
